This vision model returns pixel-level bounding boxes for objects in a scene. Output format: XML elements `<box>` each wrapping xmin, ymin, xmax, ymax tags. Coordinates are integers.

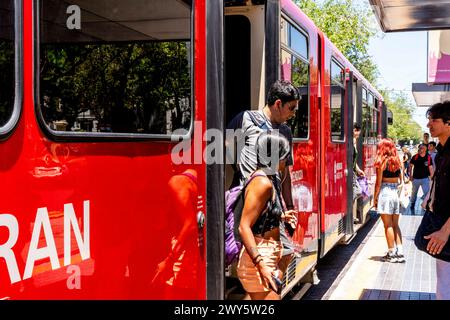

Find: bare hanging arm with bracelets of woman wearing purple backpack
<box><xmin>239</xmin><ymin>177</ymin><xmax>277</xmax><ymax>290</ymax></box>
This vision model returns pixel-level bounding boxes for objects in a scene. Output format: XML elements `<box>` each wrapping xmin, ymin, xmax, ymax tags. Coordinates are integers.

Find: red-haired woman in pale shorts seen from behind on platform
<box><xmin>374</xmin><ymin>139</ymin><xmax>405</xmax><ymax>262</ymax></box>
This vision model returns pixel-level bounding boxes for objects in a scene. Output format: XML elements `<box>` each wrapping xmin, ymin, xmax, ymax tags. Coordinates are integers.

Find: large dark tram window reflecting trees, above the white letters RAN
<box><xmin>39</xmin><ymin>0</ymin><xmax>192</xmax><ymax>136</ymax></box>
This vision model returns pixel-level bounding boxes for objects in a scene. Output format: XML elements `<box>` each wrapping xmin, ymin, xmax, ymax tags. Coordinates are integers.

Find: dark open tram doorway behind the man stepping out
<box><xmin>224</xmin><ymin>1</ymin><xmax>266</xmax><ymax>300</ymax></box>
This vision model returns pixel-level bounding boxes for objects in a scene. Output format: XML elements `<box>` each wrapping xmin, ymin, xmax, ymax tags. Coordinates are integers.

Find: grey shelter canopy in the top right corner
<box><xmin>369</xmin><ymin>0</ymin><xmax>450</xmax><ymax>32</ymax></box>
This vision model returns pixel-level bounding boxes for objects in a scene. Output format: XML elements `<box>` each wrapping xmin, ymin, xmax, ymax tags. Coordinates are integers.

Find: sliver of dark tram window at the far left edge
<box><xmin>0</xmin><ymin>0</ymin><xmax>16</xmax><ymax>130</ymax></box>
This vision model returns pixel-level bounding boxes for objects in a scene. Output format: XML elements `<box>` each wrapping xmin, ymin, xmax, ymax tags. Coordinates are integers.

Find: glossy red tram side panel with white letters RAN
<box><xmin>0</xmin><ymin>1</ymin><xmax>206</xmax><ymax>299</ymax></box>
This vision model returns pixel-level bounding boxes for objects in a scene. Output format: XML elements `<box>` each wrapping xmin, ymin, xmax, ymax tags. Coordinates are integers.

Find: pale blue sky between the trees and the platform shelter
<box><xmin>369</xmin><ymin>25</ymin><xmax>428</xmax><ymax>132</ymax></box>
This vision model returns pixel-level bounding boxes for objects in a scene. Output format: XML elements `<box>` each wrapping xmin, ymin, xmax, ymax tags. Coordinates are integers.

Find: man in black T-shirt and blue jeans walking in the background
<box><xmin>409</xmin><ymin>144</ymin><xmax>434</xmax><ymax>214</ymax></box>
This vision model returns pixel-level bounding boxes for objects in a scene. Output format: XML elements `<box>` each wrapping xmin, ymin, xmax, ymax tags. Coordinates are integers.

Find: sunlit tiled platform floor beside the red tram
<box><xmin>327</xmin><ymin>200</ymin><xmax>436</xmax><ymax>300</ymax></box>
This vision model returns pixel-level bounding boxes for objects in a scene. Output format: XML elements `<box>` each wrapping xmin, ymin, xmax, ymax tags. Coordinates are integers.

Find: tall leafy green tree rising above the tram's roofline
<box><xmin>295</xmin><ymin>0</ymin><xmax>378</xmax><ymax>83</ymax></box>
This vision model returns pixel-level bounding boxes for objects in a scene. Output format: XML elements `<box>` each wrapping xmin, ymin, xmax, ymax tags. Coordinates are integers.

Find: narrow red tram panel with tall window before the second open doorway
<box><xmin>320</xmin><ymin>50</ymin><xmax>352</xmax><ymax>256</ymax></box>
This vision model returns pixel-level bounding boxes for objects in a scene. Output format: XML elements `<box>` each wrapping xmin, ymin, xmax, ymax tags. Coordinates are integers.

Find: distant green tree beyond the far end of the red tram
<box><xmin>382</xmin><ymin>92</ymin><xmax>422</xmax><ymax>144</ymax></box>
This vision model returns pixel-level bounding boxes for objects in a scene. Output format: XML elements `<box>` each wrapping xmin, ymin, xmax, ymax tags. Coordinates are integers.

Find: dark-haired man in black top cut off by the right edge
<box><xmin>425</xmin><ymin>101</ymin><xmax>450</xmax><ymax>300</ymax></box>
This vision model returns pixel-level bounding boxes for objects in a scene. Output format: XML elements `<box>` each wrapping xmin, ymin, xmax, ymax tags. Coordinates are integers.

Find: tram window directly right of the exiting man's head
<box><xmin>281</xmin><ymin>50</ymin><xmax>309</xmax><ymax>139</ymax></box>
